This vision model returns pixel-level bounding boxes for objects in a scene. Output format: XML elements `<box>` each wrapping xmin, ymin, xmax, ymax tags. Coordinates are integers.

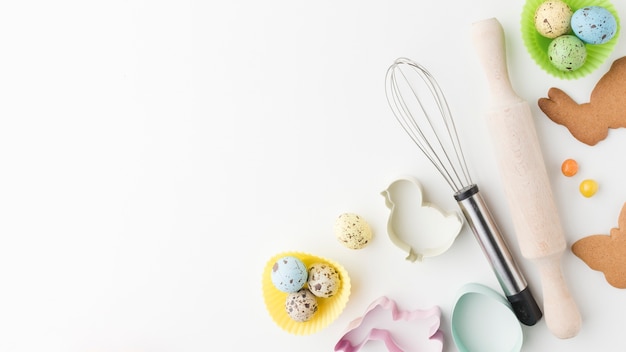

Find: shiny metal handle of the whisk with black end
<box><xmin>454</xmin><ymin>184</ymin><xmax>542</xmax><ymax>326</ymax></box>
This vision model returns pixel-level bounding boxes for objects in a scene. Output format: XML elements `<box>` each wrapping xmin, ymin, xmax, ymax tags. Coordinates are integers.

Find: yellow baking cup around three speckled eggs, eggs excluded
<box><xmin>262</xmin><ymin>252</ymin><xmax>350</xmax><ymax>335</ymax></box>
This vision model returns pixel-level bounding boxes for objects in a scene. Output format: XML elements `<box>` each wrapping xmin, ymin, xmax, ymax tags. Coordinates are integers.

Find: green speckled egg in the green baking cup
<box><xmin>548</xmin><ymin>35</ymin><xmax>587</xmax><ymax>72</ymax></box>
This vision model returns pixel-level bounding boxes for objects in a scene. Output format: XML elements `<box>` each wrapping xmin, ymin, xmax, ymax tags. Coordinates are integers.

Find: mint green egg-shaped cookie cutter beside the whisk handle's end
<box><xmin>451</xmin><ymin>283</ymin><xmax>524</xmax><ymax>352</ymax></box>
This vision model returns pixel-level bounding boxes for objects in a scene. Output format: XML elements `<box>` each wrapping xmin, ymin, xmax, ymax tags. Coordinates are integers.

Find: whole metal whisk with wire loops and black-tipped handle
<box><xmin>385</xmin><ymin>58</ymin><xmax>542</xmax><ymax>325</ymax></box>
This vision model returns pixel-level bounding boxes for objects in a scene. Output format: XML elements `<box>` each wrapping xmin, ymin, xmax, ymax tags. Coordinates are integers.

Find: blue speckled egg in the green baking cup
<box><xmin>571</xmin><ymin>6</ymin><xmax>617</xmax><ymax>44</ymax></box>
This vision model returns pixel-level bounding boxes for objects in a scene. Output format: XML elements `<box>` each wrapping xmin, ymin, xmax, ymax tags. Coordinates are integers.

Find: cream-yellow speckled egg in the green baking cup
<box><xmin>535</xmin><ymin>0</ymin><xmax>574</xmax><ymax>38</ymax></box>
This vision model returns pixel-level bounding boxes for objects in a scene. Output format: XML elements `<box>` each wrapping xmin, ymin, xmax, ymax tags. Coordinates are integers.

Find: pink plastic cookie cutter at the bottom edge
<box><xmin>335</xmin><ymin>296</ymin><xmax>443</xmax><ymax>352</ymax></box>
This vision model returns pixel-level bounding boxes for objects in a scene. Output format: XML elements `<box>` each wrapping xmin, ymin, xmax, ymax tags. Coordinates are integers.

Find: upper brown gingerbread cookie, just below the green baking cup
<box><xmin>538</xmin><ymin>57</ymin><xmax>626</xmax><ymax>146</ymax></box>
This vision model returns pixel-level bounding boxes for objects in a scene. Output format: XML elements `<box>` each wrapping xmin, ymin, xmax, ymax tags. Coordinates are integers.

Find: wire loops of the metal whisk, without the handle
<box><xmin>385</xmin><ymin>58</ymin><xmax>472</xmax><ymax>192</ymax></box>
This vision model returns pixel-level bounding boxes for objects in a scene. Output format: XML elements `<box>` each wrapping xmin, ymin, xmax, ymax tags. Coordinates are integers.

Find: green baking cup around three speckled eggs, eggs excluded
<box><xmin>521</xmin><ymin>0</ymin><xmax>621</xmax><ymax>79</ymax></box>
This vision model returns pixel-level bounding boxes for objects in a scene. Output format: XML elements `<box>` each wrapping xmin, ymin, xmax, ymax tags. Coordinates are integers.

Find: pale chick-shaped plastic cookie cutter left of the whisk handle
<box><xmin>381</xmin><ymin>176</ymin><xmax>463</xmax><ymax>262</ymax></box>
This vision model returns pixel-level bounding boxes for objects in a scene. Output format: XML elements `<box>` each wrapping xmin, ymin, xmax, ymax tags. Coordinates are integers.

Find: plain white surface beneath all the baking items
<box><xmin>0</xmin><ymin>0</ymin><xmax>626</xmax><ymax>352</ymax></box>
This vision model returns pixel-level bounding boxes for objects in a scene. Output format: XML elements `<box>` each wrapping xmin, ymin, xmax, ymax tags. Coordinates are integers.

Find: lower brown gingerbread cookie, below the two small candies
<box><xmin>572</xmin><ymin>203</ymin><xmax>626</xmax><ymax>288</ymax></box>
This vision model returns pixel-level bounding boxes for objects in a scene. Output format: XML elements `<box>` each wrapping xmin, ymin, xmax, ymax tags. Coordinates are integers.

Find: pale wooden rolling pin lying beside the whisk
<box><xmin>472</xmin><ymin>18</ymin><xmax>581</xmax><ymax>339</ymax></box>
